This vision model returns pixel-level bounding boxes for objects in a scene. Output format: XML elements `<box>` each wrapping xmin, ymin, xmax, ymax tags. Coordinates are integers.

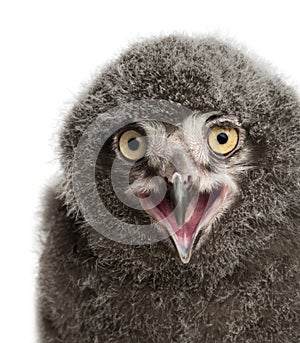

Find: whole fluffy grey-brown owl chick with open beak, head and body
<box><xmin>38</xmin><ymin>35</ymin><xmax>300</xmax><ymax>343</ymax></box>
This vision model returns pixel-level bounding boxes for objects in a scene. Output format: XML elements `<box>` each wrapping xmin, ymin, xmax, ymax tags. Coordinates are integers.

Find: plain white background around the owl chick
<box><xmin>0</xmin><ymin>0</ymin><xmax>300</xmax><ymax>343</ymax></box>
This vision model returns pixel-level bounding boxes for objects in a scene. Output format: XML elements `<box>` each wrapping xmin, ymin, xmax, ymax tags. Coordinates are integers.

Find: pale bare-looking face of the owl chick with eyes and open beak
<box><xmin>106</xmin><ymin>112</ymin><xmax>251</xmax><ymax>263</ymax></box>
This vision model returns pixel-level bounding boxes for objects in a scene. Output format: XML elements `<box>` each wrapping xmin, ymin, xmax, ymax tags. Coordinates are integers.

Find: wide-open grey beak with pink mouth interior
<box><xmin>140</xmin><ymin>172</ymin><xmax>227</xmax><ymax>263</ymax></box>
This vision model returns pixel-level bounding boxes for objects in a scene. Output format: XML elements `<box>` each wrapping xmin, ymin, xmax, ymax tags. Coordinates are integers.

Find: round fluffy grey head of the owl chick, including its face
<box><xmin>60</xmin><ymin>36</ymin><xmax>299</xmax><ymax>270</ymax></box>
